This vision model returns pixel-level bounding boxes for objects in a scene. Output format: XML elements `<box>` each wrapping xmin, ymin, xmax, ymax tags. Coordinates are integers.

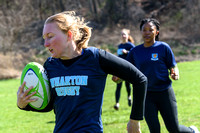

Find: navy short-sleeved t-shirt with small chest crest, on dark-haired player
<box><xmin>127</xmin><ymin>41</ymin><xmax>176</xmax><ymax>91</ymax></box>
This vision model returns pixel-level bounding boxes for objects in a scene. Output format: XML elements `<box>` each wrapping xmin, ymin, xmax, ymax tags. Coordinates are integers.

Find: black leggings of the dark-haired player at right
<box><xmin>145</xmin><ymin>88</ymin><xmax>192</xmax><ymax>133</ymax></box>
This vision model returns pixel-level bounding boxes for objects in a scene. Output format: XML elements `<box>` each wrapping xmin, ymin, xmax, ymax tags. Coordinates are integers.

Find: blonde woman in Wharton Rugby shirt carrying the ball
<box><xmin>17</xmin><ymin>11</ymin><xmax>147</xmax><ymax>133</ymax></box>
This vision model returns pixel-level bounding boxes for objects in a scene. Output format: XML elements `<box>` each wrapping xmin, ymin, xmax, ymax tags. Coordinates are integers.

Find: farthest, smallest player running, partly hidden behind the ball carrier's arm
<box><xmin>112</xmin><ymin>29</ymin><xmax>135</xmax><ymax>110</ymax></box>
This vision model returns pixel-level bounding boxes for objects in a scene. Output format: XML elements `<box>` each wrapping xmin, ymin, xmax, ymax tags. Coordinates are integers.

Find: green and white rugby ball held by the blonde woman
<box><xmin>21</xmin><ymin>62</ymin><xmax>50</xmax><ymax>110</ymax></box>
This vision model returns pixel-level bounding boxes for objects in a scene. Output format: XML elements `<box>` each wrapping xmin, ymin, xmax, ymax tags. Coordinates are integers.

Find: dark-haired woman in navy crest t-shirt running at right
<box><xmin>127</xmin><ymin>18</ymin><xmax>199</xmax><ymax>133</ymax></box>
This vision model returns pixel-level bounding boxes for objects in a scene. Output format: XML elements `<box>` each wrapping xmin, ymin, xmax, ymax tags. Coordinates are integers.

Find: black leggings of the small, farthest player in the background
<box><xmin>115</xmin><ymin>81</ymin><xmax>131</xmax><ymax>103</ymax></box>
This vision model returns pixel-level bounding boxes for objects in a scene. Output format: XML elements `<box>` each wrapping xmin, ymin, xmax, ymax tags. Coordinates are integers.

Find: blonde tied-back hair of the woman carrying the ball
<box><xmin>45</xmin><ymin>11</ymin><xmax>91</xmax><ymax>49</ymax></box>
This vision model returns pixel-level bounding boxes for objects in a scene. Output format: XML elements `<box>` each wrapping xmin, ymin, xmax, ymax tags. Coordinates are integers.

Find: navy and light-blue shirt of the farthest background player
<box><xmin>117</xmin><ymin>42</ymin><xmax>135</xmax><ymax>59</ymax></box>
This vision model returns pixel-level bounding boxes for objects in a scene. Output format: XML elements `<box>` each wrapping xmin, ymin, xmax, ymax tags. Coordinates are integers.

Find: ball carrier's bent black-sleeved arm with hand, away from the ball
<box><xmin>99</xmin><ymin>50</ymin><xmax>147</xmax><ymax>131</ymax></box>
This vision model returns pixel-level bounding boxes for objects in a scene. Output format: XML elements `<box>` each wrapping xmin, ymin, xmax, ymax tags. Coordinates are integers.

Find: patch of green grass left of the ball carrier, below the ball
<box><xmin>0</xmin><ymin>79</ymin><xmax>55</xmax><ymax>133</ymax></box>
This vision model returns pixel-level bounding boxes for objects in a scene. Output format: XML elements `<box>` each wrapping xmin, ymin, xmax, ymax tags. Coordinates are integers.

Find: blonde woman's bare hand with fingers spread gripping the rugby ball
<box><xmin>17</xmin><ymin>82</ymin><xmax>38</xmax><ymax>109</ymax></box>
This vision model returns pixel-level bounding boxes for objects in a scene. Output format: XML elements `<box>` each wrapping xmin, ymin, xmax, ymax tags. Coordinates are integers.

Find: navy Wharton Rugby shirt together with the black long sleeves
<box><xmin>20</xmin><ymin>47</ymin><xmax>147</xmax><ymax>133</ymax></box>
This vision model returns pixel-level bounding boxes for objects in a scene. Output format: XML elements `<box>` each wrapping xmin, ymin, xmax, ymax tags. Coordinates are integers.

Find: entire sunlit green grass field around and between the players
<box><xmin>0</xmin><ymin>61</ymin><xmax>200</xmax><ymax>133</ymax></box>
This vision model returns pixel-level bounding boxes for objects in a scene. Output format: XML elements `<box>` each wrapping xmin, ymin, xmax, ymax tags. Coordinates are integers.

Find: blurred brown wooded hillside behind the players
<box><xmin>0</xmin><ymin>0</ymin><xmax>200</xmax><ymax>79</ymax></box>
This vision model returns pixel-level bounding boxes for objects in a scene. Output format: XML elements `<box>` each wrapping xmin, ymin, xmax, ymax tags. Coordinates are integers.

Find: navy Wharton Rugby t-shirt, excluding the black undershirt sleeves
<box><xmin>44</xmin><ymin>48</ymin><xmax>107</xmax><ymax>133</ymax></box>
